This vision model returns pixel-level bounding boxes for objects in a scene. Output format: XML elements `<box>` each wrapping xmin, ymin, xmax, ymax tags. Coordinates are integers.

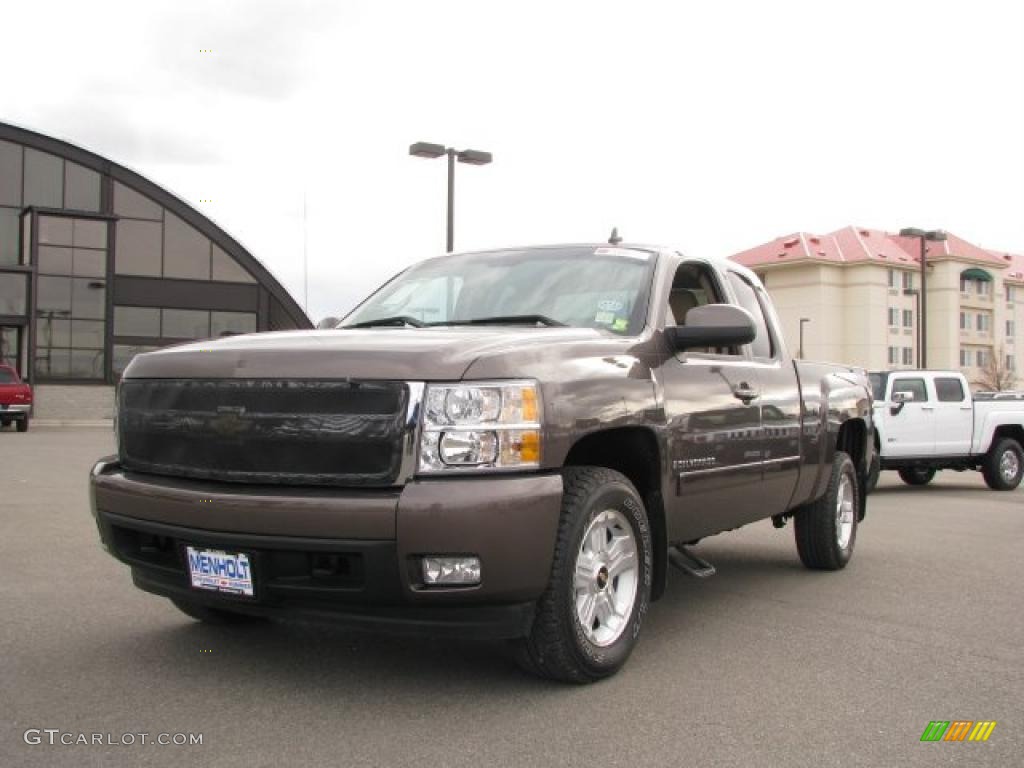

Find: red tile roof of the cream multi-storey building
<box><xmin>729</xmin><ymin>226</ymin><xmax>1011</xmax><ymax>269</ymax></box>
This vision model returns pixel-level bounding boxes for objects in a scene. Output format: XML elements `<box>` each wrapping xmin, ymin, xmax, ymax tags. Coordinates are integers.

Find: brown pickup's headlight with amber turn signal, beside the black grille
<box><xmin>420</xmin><ymin>381</ymin><xmax>541</xmax><ymax>473</ymax></box>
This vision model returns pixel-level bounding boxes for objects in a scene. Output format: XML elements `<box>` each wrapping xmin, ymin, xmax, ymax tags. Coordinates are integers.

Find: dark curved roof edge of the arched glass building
<box><xmin>0</xmin><ymin>122</ymin><xmax>313</xmax><ymax>328</ymax></box>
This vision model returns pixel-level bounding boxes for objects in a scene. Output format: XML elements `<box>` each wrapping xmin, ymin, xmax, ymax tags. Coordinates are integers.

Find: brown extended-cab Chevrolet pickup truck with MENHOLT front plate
<box><xmin>90</xmin><ymin>245</ymin><xmax>874</xmax><ymax>682</ymax></box>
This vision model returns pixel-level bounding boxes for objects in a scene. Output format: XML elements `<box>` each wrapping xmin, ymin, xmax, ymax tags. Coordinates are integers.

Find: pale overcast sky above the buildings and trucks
<box><xmin>0</xmin><ymin>0</ymin><xmax>1024</xmax><ymax>322</ymax></box>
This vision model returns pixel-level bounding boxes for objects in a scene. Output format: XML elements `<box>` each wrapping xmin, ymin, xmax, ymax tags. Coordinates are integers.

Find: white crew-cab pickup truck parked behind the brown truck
<box><xmin>867</xmin><ymin>371</ymin><xmax>1024</xmax><ymax>490</ymax></box>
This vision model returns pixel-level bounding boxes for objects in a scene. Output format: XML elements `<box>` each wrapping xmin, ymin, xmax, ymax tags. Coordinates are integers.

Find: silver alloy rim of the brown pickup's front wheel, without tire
<box><xmin>572</xmin><ymin>509</ymin><xmax>640</xmax><ymax>647</ymax></box>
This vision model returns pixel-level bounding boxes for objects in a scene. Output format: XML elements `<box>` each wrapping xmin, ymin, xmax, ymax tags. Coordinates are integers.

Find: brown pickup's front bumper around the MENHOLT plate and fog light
<box><xmin>90</xmin><ymin>460</ymin><xmax>562</xmax><ymax>638</ymax></box>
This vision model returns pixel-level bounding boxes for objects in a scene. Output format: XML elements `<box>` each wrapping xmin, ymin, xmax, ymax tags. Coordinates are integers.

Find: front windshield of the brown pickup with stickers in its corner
<box><xmin>340</xmin><ymin>247</ymin><xmax>654</xmax><ymax>336</ymax></box>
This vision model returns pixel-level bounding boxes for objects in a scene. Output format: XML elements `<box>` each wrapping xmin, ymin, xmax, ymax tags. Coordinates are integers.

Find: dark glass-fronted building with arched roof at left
<box><xmin>0</xmin><ymin>123</ymin><xmax>311</xmax><ymax>384</ymax></box>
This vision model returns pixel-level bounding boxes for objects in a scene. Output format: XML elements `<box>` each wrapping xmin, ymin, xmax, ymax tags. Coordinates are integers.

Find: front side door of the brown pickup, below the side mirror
<box><xmin>659</xmin><ymin>261</ymin><xmax>764</xmax><ymax>541</ymax></box>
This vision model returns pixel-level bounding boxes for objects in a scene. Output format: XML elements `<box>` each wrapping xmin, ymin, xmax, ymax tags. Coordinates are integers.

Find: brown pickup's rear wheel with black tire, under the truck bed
<box><xmin>794</xmin><ymin>451</ymin><xmax>860</xmax><ymax>570</ymax></box>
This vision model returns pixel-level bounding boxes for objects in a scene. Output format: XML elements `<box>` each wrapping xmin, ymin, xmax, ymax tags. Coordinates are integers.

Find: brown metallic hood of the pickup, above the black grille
<box><xmin>124</xmin><ymin>326</ymin><xmax>622</xmax><ymax>381</ymax></box>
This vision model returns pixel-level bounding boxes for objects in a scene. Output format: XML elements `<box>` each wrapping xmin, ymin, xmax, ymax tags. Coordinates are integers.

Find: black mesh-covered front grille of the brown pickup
<box><xmin>118</xmin><ymin>379</ymin><xmax>409</xmax><ymax>486</ymax></box>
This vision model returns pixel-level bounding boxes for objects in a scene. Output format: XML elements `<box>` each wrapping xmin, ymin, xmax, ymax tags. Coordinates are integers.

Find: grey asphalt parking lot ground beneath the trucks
<box><xmin>0</xmin><ymin>428</ymin><xmax>1024</xmax><ymax>768</ymax></box>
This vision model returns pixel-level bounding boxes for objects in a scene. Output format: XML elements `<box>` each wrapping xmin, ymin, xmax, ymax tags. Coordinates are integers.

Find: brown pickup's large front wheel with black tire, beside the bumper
<box><xmin>516</xmin><ymin>467</ymin><xmax>653</xmax><ymax>683</ymax></box>
